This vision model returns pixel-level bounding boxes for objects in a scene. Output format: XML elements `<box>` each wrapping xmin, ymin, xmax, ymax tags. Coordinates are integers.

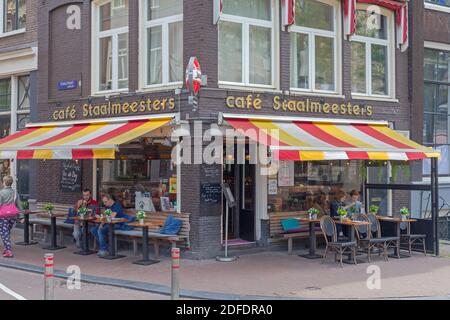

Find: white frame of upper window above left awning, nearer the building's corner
<box><xmin>139</xmin><ymin>0</ymin><xmax>184</xmax><ymax>91</ymax></box>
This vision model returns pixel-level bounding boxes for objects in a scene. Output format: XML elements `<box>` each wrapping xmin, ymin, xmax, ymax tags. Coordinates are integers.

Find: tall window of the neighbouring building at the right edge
<box><xmin>423</xmin><ymin>48</ymin><xmax>450</xmax><ymax>175</ymax></box>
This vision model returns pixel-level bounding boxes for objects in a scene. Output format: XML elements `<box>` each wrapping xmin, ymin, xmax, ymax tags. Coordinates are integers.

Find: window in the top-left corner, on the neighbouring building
<box><xmin>0</xmin><ymin>0</ymin><xmax>27</xmax><ymax>33</ymax></box>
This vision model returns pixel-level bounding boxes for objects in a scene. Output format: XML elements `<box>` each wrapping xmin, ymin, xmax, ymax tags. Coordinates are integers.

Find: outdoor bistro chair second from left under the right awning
<box><xmin>353</xmin><ymin>214</ymin><xmax>393</xmax><ymax>263</ymax></box>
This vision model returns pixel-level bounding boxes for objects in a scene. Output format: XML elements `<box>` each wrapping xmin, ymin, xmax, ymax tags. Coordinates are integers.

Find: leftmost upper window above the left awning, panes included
<box><xmin>94</xmin><ymin>0</ymin><xmax>128</xmax><ymax>92</ymax></box>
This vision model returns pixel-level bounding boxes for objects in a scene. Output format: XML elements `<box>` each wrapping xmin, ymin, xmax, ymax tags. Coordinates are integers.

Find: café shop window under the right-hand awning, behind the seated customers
<box><xmin>267</xmin><ymin>161</ymin><xmax>362</xmax><ymax>215</ymax></box>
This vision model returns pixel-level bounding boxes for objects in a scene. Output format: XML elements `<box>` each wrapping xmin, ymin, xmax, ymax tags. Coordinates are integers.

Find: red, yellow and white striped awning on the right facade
<box><xmin>224</xmin><ymin>115</ymin><xmax>440</xmax><ymax>161</ymax></box>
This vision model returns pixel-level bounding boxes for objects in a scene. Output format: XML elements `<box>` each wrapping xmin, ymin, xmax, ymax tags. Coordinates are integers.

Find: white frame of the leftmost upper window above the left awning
<box><xmin>91</xmin><ymin>0</ymin><xmax>130</xmax><ymax>95</ymax></box>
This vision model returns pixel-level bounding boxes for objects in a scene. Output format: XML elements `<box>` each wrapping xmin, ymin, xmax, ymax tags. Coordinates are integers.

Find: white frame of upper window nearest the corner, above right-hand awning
<box><xmin>217</xmin><ymin>0</ymin><xmax>279</xmax><ymax>90</ymax></box>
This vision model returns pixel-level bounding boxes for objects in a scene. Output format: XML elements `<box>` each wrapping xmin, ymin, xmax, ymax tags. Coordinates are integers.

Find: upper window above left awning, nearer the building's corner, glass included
<box><xmin>142</xmin><ymin>0</ymin><xmax>184</xmax><ymax>87</ymax></box>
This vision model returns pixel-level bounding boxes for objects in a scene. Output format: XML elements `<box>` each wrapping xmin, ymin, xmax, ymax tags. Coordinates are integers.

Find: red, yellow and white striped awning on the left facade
<box><xmin>0</xmin><ymin>115</ymin><xmax>174</xmax><ymax>159</ymax></box>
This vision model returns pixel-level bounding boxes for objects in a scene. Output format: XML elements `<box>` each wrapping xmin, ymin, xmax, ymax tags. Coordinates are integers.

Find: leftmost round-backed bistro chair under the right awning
<box><xmin>320</xmin><ymin>216</ymin><xmax>357</xmax><ymax>268</ymax></box>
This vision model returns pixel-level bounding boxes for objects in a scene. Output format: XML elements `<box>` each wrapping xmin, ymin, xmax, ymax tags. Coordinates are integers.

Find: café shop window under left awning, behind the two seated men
<box><xmin>100</xmin><ymin>137</ymin><xmax>177</xmax><ymax>211</ymax></box>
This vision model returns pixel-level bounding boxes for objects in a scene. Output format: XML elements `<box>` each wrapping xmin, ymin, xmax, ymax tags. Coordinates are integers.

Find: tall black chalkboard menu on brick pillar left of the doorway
<box><xmin>200</xmin><ymin>164</ymin><xmax>222</xmax><ymax>216</ymax></box>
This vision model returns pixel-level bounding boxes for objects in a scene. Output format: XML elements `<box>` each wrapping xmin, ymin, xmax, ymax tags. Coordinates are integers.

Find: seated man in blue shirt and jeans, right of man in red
<box><xmin>91</xmin><ymin>194</ymin><xmax>134</xmax><ymax>257</ymax></box>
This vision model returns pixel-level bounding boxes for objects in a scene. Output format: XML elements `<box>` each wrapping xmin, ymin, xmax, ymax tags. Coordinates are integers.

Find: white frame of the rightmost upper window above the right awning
<box><xmin>351</xmin><ymin>4</ymin><xmax>396</xmax><ymax>99</ymax></box>
